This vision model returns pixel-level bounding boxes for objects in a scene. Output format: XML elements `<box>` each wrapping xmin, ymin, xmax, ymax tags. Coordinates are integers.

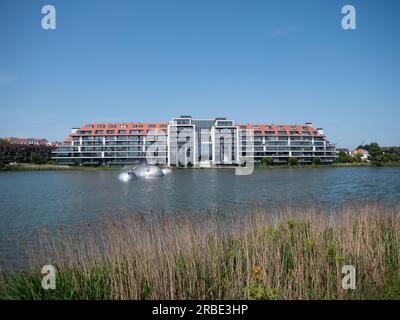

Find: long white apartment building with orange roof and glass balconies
<box><xmin>53</xmin><ymin>116</ymin><xmax>336</xmax><ymax>167</ymax></box>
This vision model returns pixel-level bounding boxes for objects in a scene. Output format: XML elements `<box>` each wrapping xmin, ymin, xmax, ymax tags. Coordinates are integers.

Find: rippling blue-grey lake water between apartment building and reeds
<box><xmin>0</xmin><ymin>167</ymin><xmax>400</xmax><ymax>241</ymax></box>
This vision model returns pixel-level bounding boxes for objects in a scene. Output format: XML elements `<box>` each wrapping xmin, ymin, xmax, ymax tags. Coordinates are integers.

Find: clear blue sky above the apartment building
<box><xmin>0</xmin><ymin>0</ymin><xmax>400</xmax><ymax>148</ymax></box>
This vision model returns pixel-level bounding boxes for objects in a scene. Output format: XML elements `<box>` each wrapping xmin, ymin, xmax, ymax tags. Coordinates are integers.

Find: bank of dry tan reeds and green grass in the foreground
<box><xmin>0</xmin><ymin>203</ymin><xmax>400</xmax><ymax>299</ymax></box>
